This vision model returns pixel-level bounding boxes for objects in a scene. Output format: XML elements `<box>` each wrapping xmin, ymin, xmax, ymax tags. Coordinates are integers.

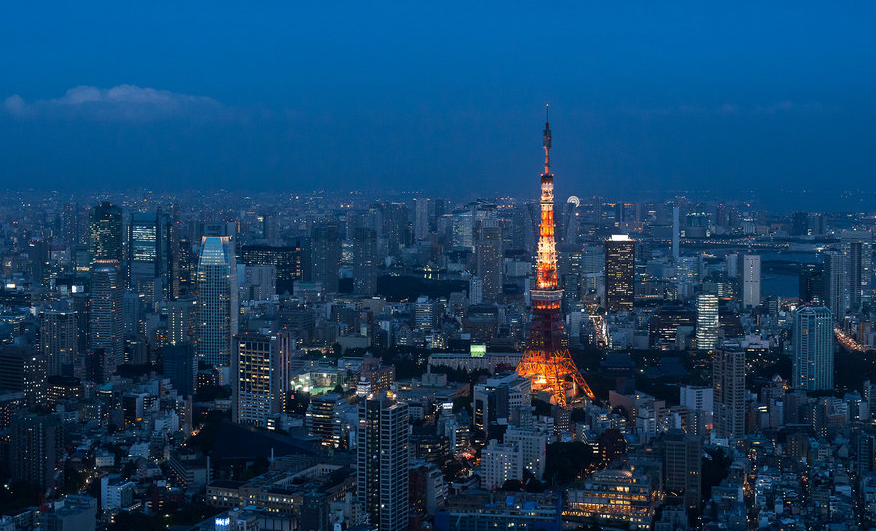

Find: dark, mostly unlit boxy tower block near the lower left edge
<box><xmin>9</xmin><ymin>415</ymin><xmax>64</xmax><ymax>492</ymax></box>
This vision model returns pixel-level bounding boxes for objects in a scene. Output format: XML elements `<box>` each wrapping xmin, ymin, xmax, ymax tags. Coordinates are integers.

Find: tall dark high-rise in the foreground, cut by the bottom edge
<box><xmin>356</xmin><ymin>398</ymin><xmax>409</xmax><ymax>531</ymax></box>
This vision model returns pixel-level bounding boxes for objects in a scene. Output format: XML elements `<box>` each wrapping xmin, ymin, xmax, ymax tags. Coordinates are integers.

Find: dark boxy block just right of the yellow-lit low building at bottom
<box><xmin>663</xmin><ymin>430</ymin><xmax>703</xmax><ymax>509</ymax></box>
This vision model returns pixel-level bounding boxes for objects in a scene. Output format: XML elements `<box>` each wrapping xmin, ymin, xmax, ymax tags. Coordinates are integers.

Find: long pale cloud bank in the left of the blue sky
<box><xmin>3</xmin><ymin>85</ymin><xmax>227</xmax><ymax>121</ymax></box>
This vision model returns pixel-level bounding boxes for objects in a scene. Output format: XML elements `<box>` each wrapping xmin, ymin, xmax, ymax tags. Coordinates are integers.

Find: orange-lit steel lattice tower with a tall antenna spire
<box><xmin>517</xmin><ymin>107</ymin><xmax>594</xmax><ymax>408</ymax></box>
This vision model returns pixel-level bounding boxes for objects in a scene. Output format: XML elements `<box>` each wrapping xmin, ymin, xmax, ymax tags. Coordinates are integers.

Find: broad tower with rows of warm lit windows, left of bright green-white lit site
<box><xmin>231</xmin><ymin>332</ymin><xmax>292</xmax><ymax>428</ymax></box>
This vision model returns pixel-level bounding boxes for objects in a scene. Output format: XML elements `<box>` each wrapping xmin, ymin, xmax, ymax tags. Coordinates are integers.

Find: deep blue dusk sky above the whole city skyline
<box><xmin>0</xmin><ymin>3</ymin><xmax>876</xmax><ymax>208</ymax></box>
